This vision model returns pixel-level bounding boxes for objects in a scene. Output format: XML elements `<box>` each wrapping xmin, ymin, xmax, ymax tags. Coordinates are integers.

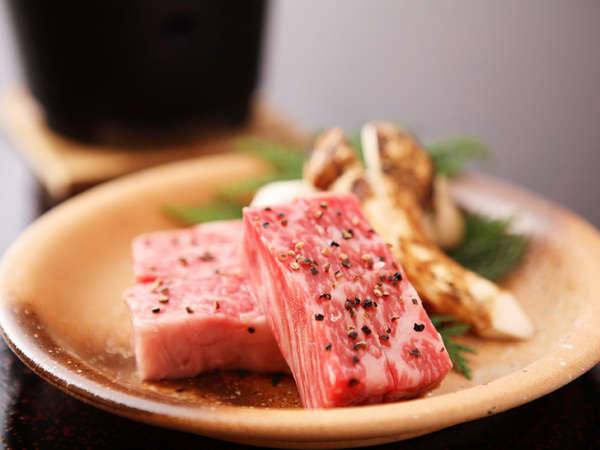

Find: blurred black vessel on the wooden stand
<box><xmin>8</xmin><ymin>0</ymin><xmax>266</xmax><ymax>142</ymax></box>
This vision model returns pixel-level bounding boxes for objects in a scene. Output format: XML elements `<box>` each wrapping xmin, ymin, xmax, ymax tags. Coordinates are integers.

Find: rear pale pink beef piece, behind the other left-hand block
<box><xmin>133</xmin><ymin>220</ymin><xmax>243</xmax><ymax>281</ymax></box>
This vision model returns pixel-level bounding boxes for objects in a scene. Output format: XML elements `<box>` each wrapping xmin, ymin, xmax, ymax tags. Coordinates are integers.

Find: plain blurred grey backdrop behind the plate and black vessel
<box><xmin>0</xmin><ymin>0</ymin><xmax>600</xmax><ymax>249</ymax></box>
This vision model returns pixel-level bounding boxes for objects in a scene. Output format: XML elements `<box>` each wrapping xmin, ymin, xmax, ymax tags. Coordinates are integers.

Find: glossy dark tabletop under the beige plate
<box><xmin>0</xmin><ymin>140</ymin><xmax>600</xmax><ymax>450</ymax></box>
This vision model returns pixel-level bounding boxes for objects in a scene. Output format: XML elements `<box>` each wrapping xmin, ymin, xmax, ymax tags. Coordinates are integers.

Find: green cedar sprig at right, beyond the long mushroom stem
<box><xmin>448</xmin><ymin>212</ymin><xmax>529</xmax><ymax>280</ymax></box>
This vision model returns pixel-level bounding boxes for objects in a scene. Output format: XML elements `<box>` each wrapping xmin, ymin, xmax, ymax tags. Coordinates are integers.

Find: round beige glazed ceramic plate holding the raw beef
<box><xmin>0</xmin><ymin>155</ymin><xmax>600</xmax><ymax>447</ymax></box>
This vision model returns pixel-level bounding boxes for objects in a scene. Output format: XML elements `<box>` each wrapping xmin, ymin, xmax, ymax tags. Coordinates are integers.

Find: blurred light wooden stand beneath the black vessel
<box><xmin>0</xmin><ymin>88</ymin><xmax>306</xmax><ymax>203</ymax></box>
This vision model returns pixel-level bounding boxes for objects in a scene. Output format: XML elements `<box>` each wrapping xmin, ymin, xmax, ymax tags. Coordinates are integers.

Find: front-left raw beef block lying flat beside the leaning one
<box><xmin>124</xmin><ymin>275</ymin><xmax>289</xmax><ymax>380</ymax></box>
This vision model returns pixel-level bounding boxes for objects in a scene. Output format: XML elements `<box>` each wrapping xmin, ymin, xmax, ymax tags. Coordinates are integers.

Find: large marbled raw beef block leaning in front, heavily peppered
<box><xmin>244</xmin><ymin>193</ymin><xmax>452</xmax><ymax>408</ymax></box>
